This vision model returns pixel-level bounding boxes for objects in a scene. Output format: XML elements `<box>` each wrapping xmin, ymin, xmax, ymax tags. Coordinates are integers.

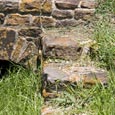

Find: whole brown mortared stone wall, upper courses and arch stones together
<box><xmin>0</xmin><ymin>0</ymin><xmax>97</xmax><ymax>67</ymax></box>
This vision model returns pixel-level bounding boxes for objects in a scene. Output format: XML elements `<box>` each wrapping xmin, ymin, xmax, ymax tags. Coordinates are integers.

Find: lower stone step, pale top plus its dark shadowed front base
<box><xmin>43</xmin><ymin>62</ymin><xmax>108</xmax><ymax>97</ymax></box>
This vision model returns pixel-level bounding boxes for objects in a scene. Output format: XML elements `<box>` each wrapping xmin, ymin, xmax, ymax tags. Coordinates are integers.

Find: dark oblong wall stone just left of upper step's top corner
<box><xmin>19</xmin><ymin>27</ymin><xmax>42</xmax><ymax>37</ymax></box>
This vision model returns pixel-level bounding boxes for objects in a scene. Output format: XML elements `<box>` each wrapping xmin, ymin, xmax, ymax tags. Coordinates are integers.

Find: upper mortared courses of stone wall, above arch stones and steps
<box><xmin>0</xmin><ymin>0</ymin><xmax>97</xmax><ymax>27</ymax></box>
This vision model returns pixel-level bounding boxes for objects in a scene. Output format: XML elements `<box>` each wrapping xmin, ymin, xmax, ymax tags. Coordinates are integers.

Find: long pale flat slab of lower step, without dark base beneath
<box><xmin>44</xmin><ymin>63</ymin><xmax>108</xmax><ymax>85</ymax></box>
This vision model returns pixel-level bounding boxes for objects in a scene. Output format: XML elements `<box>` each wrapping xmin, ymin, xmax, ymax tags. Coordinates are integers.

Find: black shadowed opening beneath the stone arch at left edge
<box><xmin>0</xmin><ymin>60</ymin><xmax>21</xmax><ymax>79</ymax></box>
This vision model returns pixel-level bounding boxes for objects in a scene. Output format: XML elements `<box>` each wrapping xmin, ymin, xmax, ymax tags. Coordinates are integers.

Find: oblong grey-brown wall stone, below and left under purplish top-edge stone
<box><xmin>52</xmin><ymin>10</ymin><xmax>73</xmax><ymax>19</ymax></box>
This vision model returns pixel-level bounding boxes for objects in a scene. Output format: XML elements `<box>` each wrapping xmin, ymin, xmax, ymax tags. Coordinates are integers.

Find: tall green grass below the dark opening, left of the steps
<box><xmin>0</xmin><ymin>67</ymin><xmax>42</xmax><ymax>115</ymax></box>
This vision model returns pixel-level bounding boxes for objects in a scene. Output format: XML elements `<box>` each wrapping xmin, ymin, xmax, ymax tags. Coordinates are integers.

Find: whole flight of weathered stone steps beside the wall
<box><xmin>42</xmin><ymin>25</ymin><xmax>108</xmax><ymax>115</ymax></box>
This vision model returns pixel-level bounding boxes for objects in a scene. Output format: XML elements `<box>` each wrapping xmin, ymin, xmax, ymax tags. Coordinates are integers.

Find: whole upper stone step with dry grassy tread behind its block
<box><xmin>43</xmin><ymin>27</ymin><xmax>94</xmax><ymax>60</ymax></box>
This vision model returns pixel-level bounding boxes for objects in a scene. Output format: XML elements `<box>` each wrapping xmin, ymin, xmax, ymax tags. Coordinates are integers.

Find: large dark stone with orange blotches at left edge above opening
<box><xmin>0</xmin><ymin>28</ymin><xmax>17</xmax><ymax>60</ymax></box>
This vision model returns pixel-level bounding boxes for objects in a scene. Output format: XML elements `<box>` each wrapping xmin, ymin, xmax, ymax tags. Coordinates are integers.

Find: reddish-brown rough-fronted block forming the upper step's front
<box><xmin>43</xmin><ymin>36</ymin><xmax>82</xmax><ymax>60</ymax></box>
